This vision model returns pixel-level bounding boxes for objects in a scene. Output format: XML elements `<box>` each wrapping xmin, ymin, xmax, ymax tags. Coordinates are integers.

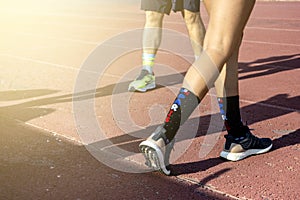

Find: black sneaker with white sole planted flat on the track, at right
<box><xmin>220</xmin><ymin>126</ymin><xmax>272</xmax><ymax>161</ymax></box>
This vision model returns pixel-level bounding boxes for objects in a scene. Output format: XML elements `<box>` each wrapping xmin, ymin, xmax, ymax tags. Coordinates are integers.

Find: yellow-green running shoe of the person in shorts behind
<box><xmin>128</xmin><ymin>69</ymin><xmax>156</xmax><ymax>92</ymax></box>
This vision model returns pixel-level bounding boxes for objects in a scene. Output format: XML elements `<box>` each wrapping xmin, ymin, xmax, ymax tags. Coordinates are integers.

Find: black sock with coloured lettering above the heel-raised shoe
<box><xmin>164</xmin><ymin>88</ymin><xmax>200</xmax><ymax>142</ymax></box>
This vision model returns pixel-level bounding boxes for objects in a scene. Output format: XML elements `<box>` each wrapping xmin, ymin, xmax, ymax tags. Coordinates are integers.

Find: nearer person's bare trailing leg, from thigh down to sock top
<box><xmin>183</xmin><ymin>0</ymin><xmax>255</xmax><ymax>98</ymax></box>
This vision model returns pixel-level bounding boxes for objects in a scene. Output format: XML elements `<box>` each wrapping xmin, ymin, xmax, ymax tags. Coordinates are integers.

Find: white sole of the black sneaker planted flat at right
<box><xmin>220</xmin><ymin>144</ymin><xmax>273</xmax><ymax>161</ymax></box>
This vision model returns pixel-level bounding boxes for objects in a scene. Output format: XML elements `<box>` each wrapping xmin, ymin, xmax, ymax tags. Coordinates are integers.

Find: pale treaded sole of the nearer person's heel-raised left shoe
<box><xmin>139</xmin><ymin>140</ymin><xmax>171</xmax><ymax>175</ymax></box>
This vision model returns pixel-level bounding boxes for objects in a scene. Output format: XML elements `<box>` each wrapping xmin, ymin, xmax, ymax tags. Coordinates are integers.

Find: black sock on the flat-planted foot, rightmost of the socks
<box><xmin>218</xmin><ymin>96</ymin><xmax>246</xmax><ymax>137</ymax></box>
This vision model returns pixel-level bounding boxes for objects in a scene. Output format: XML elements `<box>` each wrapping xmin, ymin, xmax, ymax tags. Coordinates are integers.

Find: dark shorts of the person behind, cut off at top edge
<box><xmin>141</xmin><ymin>0</ymin><xmax>200</xmax><ymax>14</ymax></box>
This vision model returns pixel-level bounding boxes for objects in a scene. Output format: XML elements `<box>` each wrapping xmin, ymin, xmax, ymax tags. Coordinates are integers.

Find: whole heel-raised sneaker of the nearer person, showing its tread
<box><xmin>139</xmin><ymin>126</ymin><xmax>175</xmax><ymax>175</ymax></box>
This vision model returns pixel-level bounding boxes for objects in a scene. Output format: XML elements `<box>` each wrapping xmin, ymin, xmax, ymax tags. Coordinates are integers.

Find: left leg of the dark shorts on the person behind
<box><xmin>141</xmin><ymin>0</ymin><xmax>172</xmax><ymax>14</ymax></box>
